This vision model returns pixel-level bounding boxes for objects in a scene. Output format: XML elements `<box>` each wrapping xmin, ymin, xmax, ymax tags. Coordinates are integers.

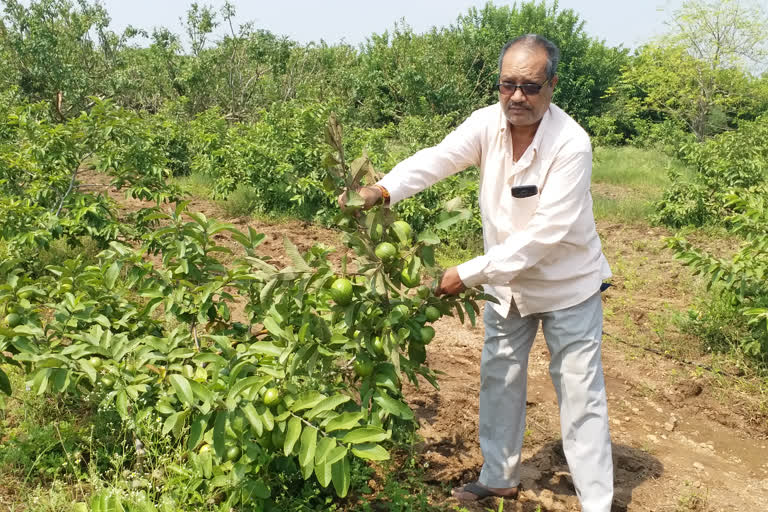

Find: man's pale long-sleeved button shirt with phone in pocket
<box><xmin>379</xmin><ymin>103</ymin><xmax>611</xmax><ymax>316</ymax></box>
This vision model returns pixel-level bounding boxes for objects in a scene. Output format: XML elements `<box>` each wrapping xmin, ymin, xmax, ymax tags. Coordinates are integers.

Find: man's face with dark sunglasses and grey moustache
<box><xmin>499</xmin><ymin>45</ymin><xmax>557</xmax><ymax>126</ymax></box>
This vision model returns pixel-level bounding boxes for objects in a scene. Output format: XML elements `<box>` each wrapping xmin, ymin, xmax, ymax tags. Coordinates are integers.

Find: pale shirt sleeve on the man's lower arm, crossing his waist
<box><xmin>457</xmin><ymin>150</ymin><xmax>592</xmax><ymax>286</ymax></box>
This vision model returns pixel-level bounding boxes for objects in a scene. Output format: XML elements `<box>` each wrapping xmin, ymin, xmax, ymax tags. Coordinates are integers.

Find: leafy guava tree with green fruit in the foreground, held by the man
<box><xmin>0</xmin><ymin>114</ymin><xmax>487</xmax><ymax>510</ymax></box>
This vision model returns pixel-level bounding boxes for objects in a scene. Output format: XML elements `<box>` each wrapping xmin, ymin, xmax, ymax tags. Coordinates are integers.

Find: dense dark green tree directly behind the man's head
<box><xmin>356</xmin><ymin>2</ymin><xmax>627</xmax><ymax>128</ymax></box>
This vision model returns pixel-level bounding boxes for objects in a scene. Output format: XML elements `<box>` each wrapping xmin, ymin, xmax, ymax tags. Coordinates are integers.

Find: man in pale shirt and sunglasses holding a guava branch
<box><xmin>340</xmin><ymin>35</ymin><xmax>613</xmax><ymax>512</ymax></box>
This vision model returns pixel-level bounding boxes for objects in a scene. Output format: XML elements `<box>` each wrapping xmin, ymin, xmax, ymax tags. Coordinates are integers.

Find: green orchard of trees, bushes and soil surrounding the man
<box><xmin>0</xmin><ymin>0</ymin><xmax>768</xmax><ymax>512</ymax></box>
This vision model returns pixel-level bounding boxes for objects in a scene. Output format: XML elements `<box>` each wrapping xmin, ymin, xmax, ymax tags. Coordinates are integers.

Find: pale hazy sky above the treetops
<box><xmin>93</xmin><ymin>0</ymin><xmax>683</xmax><ymax>48</ymax></box>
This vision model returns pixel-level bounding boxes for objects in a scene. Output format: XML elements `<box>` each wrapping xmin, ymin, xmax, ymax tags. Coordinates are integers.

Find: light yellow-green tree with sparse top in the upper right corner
<box><xmin>610</xmin><ymin>0</ymin><xmax>768</xmax><ymax>140</ymax></box>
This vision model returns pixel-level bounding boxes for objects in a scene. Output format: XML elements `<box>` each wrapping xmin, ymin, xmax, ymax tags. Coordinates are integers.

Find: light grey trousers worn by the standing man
<box><xmin>480</xmin><ymin>292</ymin><xmax>613</xmax><ymax>512</ymax></box>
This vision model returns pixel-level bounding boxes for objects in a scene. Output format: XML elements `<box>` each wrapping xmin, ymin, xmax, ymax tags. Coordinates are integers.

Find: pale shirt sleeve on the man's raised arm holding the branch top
<box><xmin>377</xmin><ymin>113</ymin><xmax>484</xmax><ymax>206</ymax></box>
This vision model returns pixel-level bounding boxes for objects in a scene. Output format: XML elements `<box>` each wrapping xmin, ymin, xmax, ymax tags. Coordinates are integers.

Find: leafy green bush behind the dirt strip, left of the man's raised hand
<box><xmin>182</xmin><ymin>102</ymin><xmax>335</xmax><ymax>219</ymax></box>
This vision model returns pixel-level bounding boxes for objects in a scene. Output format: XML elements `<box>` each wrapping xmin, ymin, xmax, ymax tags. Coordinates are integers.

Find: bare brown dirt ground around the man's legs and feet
<box><xmin>409</xmin><ymin>314</ymin><xmax>768</xmax><ymax>511</ymax></box>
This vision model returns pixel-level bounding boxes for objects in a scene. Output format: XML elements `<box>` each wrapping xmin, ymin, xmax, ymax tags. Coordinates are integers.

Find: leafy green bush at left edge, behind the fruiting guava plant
<box><xmin>0</xmin><ymin>101</ymin><xmax>178</xmax><ymax>265</ymax></box>
